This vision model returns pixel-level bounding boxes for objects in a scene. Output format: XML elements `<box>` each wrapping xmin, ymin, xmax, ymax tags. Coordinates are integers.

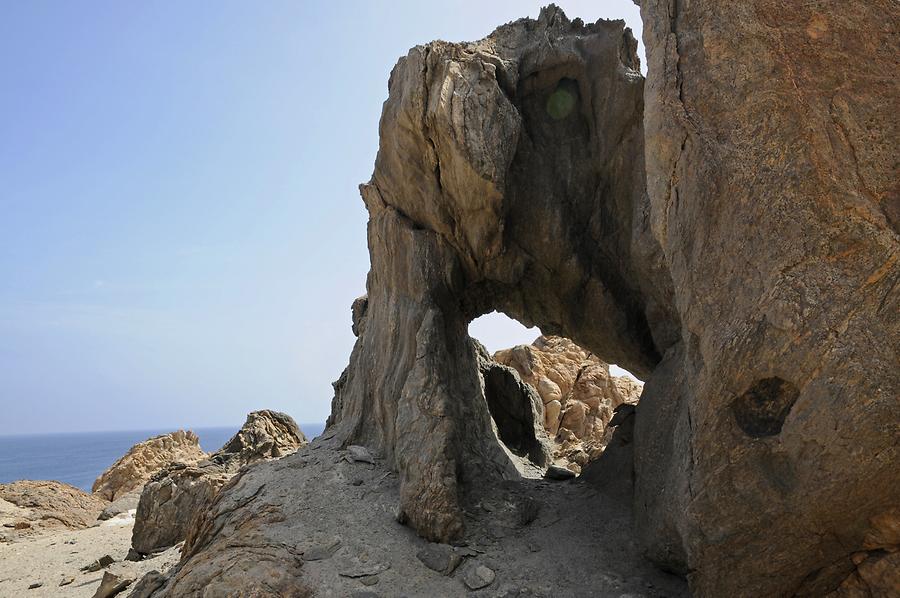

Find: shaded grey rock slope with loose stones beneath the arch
<box><xmin>126</xmin><ymin>442</ymin><xmax>687</xmax><ymax>598</ymax></box>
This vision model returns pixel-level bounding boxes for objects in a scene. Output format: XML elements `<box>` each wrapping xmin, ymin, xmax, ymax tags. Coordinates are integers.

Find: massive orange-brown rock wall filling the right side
<box><xmin>632</xmin><ymin>0</ymin><xmax>900</xmax><ymax>596</ymax></box>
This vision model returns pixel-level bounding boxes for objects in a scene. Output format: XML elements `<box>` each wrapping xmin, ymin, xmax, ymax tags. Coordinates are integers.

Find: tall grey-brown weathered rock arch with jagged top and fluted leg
<box><xmin>329</xmin><ymin>8</ymin><xmax>678</xmax><ymax>540</ymax></box>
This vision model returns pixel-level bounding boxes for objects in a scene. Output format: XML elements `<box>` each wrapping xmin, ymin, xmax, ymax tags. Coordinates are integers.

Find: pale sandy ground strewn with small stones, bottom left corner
<box><xmin>0</xmin><ymin>511</ymin><xmax>180</xmax><ymax>598</ymax></box>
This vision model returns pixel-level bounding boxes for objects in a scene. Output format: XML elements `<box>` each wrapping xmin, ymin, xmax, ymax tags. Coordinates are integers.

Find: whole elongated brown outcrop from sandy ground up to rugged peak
<box><xmin>131</xmin><ymin>410</ymin><xmax>306</xmax><ymax>555</ymax></box>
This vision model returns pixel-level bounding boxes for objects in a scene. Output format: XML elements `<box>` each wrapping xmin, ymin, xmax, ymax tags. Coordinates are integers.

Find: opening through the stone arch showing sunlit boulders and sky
<box><xmin>469</xmin><ymin>312</ymin><xmax>643</xmax><ymax>473</ymax></box>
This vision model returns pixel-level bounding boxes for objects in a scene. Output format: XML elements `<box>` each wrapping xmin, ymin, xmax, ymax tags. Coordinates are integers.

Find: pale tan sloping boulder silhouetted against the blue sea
<box><xmin>92</xmin><ymin>430</ymin><xmax>206</xmax><ymax>501</ymax></box>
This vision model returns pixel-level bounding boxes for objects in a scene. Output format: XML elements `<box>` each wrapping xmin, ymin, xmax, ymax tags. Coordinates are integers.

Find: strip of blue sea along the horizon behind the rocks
<box><xmin>0</xmin><ymin>424</ymin><xmax>325</xmax><ymax>492</ymax></box>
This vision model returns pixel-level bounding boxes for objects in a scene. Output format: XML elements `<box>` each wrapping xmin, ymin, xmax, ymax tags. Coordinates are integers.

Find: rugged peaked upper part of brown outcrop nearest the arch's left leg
<box><xmin>209</xmin><ymin>409</ymin><xmax>307</xmax><ymax>472</ymax></box>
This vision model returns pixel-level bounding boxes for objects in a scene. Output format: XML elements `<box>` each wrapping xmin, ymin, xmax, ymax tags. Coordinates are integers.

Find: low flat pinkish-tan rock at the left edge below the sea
<box><xmin>0</xmin><ymin>480</ymin><xmax>109</xmax><ymax>533</ymax></box>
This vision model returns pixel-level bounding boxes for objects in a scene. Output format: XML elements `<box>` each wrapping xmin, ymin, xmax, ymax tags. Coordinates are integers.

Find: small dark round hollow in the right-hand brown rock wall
<box><xmin>731</xmin><ymin>377</ymin><xmax>800</xmax><ymax>438</ymax></box>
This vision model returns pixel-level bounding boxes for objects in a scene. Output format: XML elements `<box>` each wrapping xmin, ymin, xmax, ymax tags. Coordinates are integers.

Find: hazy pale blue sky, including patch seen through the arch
<box><xmin>0</xmin><ymin>0</ymin><xmax>640</xmax><ymax>434</ymax></box>
